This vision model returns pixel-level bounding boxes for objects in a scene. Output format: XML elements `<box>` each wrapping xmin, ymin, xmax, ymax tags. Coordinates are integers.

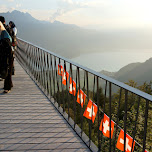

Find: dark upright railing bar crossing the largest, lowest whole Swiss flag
<box><xmin>124</xmin><ymin>90</ymin><xmax>128</xmax><ymax>151</ymax></box>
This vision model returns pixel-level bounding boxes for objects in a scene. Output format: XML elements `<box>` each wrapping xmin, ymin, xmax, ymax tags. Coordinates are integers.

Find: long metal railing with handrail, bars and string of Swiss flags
<box><xmin>16</xmin><ymin>39</ymin><xmax>152</xmax><ymax>152</ymax></box>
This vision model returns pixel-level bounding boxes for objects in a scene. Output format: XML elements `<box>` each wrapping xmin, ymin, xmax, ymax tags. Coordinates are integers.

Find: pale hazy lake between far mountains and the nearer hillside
<box><xmin>71</xmin><ymin>50</ymin><xmax>152</xmax><ymax>72</ymax></box>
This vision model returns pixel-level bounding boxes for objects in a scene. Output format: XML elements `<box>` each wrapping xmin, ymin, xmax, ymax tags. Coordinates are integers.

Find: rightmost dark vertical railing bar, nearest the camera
<box><xmin>143</xmin><ymin>100</ymin><xmax>149</xmax><ymax>152</ymax></box>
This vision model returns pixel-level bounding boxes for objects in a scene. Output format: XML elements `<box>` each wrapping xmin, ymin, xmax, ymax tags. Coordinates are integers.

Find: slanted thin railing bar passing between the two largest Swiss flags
<box><xmin>113</xmin><ymin>88</ymin><xmax>122</xmax><ymax>152</ymax></box>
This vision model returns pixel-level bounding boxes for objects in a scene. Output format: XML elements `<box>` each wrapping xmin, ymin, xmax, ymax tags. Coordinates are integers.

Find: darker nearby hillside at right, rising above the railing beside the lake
<box><xmin>101</xmin><ymin>58</ymin><xmax>152</xmax><ymax>85</ymax></box>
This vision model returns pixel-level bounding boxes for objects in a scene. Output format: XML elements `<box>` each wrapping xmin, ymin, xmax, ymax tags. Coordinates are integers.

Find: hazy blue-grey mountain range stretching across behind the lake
<box><xmin>0</xmin><ymin>10</ymin><xmax>152</xmax><ymax>58</ymax></box>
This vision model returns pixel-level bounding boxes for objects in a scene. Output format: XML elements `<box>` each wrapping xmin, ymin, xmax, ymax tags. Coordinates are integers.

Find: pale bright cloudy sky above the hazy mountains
<box><xmin>0</xmin><ymin>0</ymin><xmax>152</xmax><ymax>29</ymax></box>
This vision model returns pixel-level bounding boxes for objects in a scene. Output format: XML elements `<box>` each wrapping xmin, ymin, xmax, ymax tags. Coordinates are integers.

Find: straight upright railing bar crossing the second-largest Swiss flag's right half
<box><xmin>109</xmin><ymin>82</ymin><xmax>112</xmax><ymax>152</ymax></box>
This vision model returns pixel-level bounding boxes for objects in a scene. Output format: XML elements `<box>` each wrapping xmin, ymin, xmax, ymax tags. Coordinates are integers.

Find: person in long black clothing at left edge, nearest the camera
<box><xmin>0</xmin><ymin>21</ymin><xmax>13</xmax><ymax>93</ymax></box>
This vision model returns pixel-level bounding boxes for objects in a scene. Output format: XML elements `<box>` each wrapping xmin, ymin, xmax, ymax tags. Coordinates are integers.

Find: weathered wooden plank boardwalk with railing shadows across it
<box><xmin>0</xmin><ymin>62</ymin><xmax>90</xmax><ymax>152</ymax></box>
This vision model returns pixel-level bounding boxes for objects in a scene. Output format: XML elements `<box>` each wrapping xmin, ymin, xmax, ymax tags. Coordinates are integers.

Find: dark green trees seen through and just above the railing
<box><xmin>52</xmin><ymin>80</ymin><xmax>152</xmax><ymax>152</ymax></box>
